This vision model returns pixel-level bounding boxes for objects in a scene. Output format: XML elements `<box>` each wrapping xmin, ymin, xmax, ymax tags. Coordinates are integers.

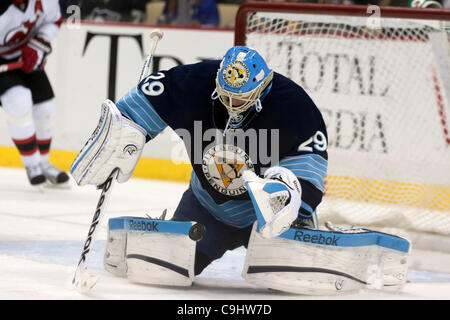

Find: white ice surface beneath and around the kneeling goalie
<box><xmin>0</xmin><ymin>168</ymin><xmax>450</xmax><ymax>300</ymax></box>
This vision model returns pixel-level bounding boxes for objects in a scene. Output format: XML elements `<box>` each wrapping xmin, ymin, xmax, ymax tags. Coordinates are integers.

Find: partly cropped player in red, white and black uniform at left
<box><xmin>0</xmin><ymin>0</ymin><xmax>69</xmax><ymax>185</ymax></box>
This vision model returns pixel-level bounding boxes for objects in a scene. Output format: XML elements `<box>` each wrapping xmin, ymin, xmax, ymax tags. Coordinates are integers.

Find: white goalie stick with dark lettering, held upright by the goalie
<box><xmin>72</xmin><ymin>29</ymin><xmax>163</xmax><ymax>292</ymax></box>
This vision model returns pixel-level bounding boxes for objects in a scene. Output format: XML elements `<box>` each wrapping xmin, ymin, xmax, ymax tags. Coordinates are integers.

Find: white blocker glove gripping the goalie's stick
<box><xmin>70</xmin><ymin>100</ymin><xmax>146</xmax><ymax>186</ymax></box>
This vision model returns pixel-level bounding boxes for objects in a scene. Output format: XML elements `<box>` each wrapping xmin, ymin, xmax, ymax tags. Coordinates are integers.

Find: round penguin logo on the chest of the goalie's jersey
<box><xmin>202</xmin><ymin>144</ymin><xmax>254</xmax><ymax>196</ymax></box>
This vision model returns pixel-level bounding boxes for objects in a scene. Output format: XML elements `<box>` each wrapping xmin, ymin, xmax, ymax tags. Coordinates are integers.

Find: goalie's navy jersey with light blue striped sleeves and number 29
<box><xmin>117</xmin><ymin>61</ymin><xmax>328</xmax><ymax>228</ymax></box>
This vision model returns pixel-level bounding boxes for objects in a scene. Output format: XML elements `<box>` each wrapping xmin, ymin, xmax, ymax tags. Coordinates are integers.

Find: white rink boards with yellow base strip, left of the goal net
<box><xmin>0</xmin><ymin>22</ymin><xmax>234</xmax><ymax>181</ymax></box>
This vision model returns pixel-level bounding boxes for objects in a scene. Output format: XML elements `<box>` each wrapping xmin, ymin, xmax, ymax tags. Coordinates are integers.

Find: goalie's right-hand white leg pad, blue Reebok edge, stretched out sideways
<box><xmin>243</xmin><ymin>222</ymin><xmax>410</xmax><ymax>295</ymax></box>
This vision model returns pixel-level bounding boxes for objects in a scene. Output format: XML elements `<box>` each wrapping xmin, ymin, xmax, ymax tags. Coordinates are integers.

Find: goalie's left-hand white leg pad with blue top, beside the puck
<box><xmin>104</xmin><ymin>217</ymin><xmax>205</xmax><ymax>286</ymax></box>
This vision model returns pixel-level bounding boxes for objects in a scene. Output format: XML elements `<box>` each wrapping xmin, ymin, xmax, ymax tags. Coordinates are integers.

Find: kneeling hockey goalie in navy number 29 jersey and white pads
<box><xmin>71</xmin><ymin>46</ymin><xmax>410</xmax><ymax>295</ymax></box>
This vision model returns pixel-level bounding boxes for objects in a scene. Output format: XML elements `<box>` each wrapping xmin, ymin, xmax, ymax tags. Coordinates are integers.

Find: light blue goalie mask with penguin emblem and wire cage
<box><xmin>212</xmin><ymin>46</ymin><xmax>273</xmax><ymax>119</ymax></box>
